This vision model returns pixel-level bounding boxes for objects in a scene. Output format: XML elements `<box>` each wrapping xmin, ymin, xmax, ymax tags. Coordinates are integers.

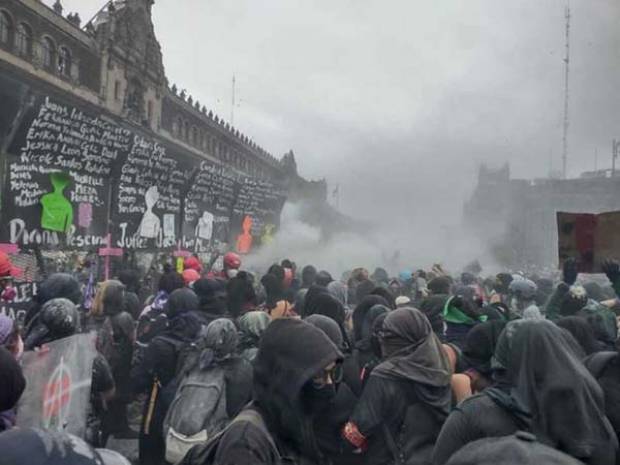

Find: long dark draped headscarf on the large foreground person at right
<box><xmin>491</xmin><ymin>320</ymin><xmax>617</xmax><ymax>461</ymax></box>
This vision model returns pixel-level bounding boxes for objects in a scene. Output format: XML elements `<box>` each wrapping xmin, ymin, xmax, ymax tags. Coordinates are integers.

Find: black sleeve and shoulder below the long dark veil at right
<box><xmin>433</xmin><ymin>393</ymin><xmax>519</xmax><ymax>465</ymax></box>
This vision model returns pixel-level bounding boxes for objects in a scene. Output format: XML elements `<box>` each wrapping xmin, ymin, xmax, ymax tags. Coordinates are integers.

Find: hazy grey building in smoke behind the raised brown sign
<box><xmin>463</xmin><ymin>165</ymin><xmax>620</xmax><ymax>268</ymax></box>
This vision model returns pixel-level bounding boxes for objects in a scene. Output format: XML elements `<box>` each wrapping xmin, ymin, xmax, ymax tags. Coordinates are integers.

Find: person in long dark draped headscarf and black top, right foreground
<box><xmin>433</xmin><ymin>320</ymin><xmax>618</xmax><ymax>465</ymax></box>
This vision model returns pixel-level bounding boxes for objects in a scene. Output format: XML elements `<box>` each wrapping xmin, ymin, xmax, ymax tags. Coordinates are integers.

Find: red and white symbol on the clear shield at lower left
<box><xmin>43</xmin><ymin>358</ymin><xmax>72</xmax><ymax>430</ymax></box>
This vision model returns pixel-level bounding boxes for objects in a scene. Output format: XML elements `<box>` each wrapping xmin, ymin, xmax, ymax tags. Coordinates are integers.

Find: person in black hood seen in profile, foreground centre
<box><xmin>183</xmin><ymin>318</ymin><xmax>341</xmax><ymax>465</ymax></box>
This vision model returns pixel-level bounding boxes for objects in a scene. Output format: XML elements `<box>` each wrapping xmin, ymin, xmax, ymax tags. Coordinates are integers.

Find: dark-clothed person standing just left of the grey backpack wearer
<box><xmin>131</xmin><ymin>288</ymin><xmax>201</xmax><ymax>465</ymax></box>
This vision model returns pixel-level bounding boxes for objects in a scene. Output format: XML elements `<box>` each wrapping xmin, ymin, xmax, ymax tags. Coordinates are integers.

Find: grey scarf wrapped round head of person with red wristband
<box><xmin>372</xmin><ymin>308</ymin><xmax>451</xmax><ymax>414</ymax></box>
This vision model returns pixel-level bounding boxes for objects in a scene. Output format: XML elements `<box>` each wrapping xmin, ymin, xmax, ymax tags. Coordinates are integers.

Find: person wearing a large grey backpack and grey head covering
<box><xmin>164</xmin><ymin>318</ymin><xmax>252</xmax><ymax>464</ymax></box>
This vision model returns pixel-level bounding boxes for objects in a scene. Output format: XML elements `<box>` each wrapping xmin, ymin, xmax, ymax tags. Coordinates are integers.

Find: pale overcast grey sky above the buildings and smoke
<box><xmin>46</xmin><ymin>0</ymin><xmax>620</xmax><ymax>223</ymax></box>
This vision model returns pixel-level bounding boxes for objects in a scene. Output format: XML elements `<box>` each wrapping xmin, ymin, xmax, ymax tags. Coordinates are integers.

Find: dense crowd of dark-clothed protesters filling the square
<box><xmin>0</xmin><ymin>253</ymin><xmax>620</xmax><ymax>465</ymax></box>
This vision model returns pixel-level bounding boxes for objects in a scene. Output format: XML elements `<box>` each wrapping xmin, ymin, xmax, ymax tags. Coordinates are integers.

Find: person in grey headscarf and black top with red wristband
<box><xmin>343</xmin><ymin>308</ymin><xmax>451</xmax><ymax>465</ymax></box>
